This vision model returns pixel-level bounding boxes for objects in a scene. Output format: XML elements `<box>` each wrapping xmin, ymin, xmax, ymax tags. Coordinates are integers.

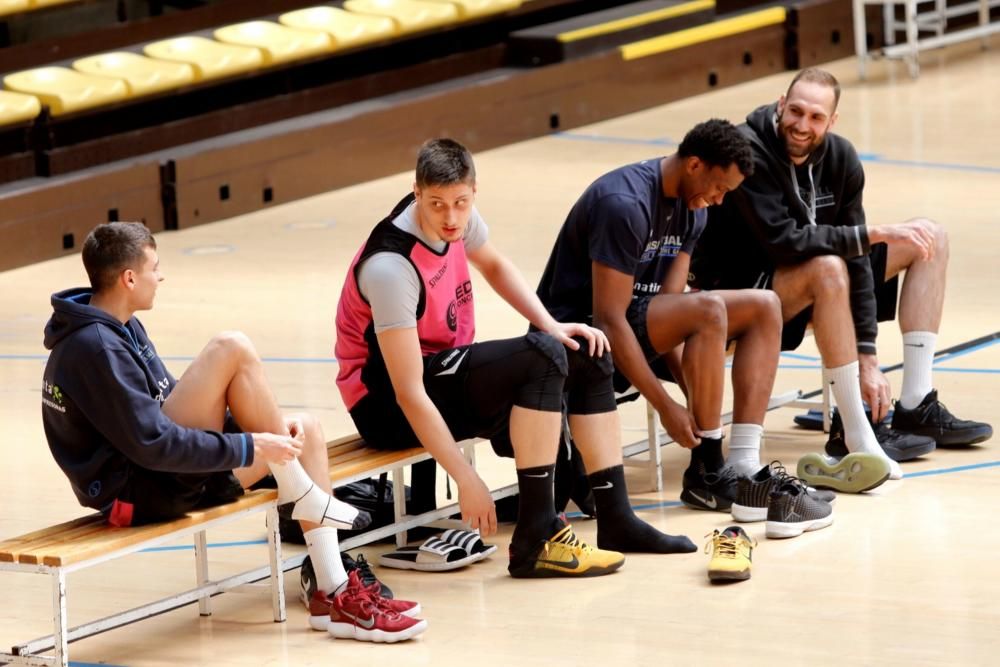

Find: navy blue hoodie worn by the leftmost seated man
<box><xmin>42</xmin><ymin>288</ymin><xmax>253</xmax><ymax>510</ymax></box>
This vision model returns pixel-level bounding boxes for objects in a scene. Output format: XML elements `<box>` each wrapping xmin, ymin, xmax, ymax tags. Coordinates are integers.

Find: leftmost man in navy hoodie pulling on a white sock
<box><xmin>42</xmin><ymin>222</ymin><xmax>422</xmax><ymax>632</ymax></box>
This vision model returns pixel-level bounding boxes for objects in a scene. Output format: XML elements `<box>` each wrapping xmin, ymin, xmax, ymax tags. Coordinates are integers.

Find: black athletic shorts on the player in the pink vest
<box><xmin>351</xmin><ymin>333</ymin><xmax>567</xmax><ymax>449</ymax></box>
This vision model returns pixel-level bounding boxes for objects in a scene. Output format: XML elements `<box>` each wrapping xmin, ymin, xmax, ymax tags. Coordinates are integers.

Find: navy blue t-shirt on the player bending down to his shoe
<box><xmin>538</xmin><ymin>158</ymin><xmax>707</xmax><ymax>323</ymax></box>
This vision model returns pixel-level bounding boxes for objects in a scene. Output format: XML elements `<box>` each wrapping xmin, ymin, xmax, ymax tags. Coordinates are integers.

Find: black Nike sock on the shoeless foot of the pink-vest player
<box><xmin>588</xmin><ymin>465</ymin><xmax>697</xmax><ymax>554</ymax></box>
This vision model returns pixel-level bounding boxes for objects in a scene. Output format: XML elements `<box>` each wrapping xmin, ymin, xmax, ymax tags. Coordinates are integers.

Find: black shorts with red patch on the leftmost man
<box><xmin>106</xmin><ymin>465</ymin><xmax>243</xmax><ymax>527</ymax></box>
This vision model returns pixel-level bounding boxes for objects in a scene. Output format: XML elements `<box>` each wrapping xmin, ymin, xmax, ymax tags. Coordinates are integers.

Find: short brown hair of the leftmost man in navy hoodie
<box><xmin>83</xmin><ymin>222</ymin><xmax>156</xmax><ymax>292</ymax></box>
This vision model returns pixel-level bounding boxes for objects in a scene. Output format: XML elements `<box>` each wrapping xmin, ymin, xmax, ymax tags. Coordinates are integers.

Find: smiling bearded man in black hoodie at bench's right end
<box><xmin>692</xmin><ymin>68</ymin><xmax>993</xmax><ymax>479</ymax></box>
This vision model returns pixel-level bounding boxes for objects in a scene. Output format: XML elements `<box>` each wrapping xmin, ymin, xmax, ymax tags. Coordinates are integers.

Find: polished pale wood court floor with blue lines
<box><xmin>0</xmin><ymin>47</ymin><xmax>1000</xmax><ymax>667</ymax></box>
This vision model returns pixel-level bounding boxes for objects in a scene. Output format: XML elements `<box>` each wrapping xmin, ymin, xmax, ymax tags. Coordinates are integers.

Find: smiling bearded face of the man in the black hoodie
<box><xmin>777</xmin><ymin>81</ymin><xmax>837</xmax><ymax>164</ymax></box>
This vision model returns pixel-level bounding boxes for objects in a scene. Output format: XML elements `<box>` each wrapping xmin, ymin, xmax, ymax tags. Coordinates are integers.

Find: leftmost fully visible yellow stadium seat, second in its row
<box><xmin>3</xmin><ymin>67</ymin><xmax>129</xmax><ymax>116</ymax></box>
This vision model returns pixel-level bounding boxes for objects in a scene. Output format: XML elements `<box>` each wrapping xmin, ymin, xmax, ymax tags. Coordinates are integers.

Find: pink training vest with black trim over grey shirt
<box><xmin>334</xmin><ymin>198</ymin><xmax>476</xmax><ymax>410</ymax></box>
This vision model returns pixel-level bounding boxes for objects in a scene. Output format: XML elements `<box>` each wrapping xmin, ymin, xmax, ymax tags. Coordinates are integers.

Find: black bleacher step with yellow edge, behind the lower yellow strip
<box><xmin>508</xmin><ymin>0</ymin><xmax>715</xmax><ymax>67</ymax></box>
